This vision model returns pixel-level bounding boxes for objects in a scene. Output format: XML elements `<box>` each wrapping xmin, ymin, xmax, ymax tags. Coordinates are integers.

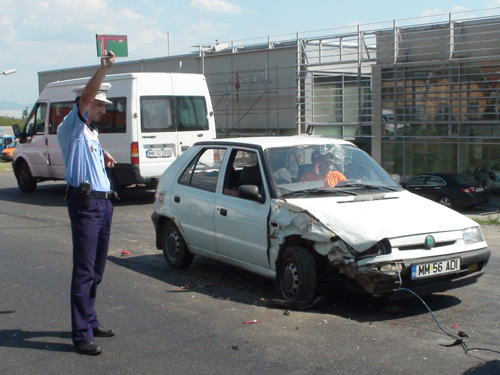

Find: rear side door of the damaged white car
<box><xmin>171</xmin><ymin>147</ymin><xmax>226</xmax><ymax>252</ymax></box>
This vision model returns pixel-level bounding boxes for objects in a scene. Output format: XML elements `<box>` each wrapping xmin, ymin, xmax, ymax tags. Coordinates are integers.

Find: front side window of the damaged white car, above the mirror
<box><xmin>223</xmin><ymin>150</ymin><xmax>264</xmax><ymax>197</ymax></box>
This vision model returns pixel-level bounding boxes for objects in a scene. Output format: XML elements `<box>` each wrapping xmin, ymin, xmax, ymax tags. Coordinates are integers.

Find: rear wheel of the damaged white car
<box><xmin>162</xmin><ymin>222</ymin><xmax>193</xmax><ymax>269</ymax></box>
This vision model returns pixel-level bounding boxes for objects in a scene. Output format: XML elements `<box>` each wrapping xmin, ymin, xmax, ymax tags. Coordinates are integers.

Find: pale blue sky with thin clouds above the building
<box><xmin>0</xmin><ymin>0</ymin><xmax>500</xmax><ymax>109</ymax></box>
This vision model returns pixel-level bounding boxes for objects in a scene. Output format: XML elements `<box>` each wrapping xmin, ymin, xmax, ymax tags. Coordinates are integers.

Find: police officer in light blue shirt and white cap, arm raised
<box><xmin>57</xmin><ymin>52</ymin><xmax>115</xmax><ymax>355</ymax></box>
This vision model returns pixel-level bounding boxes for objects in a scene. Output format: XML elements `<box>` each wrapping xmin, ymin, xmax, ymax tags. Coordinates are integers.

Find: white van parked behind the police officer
<box><xmin>12</xmin><ymin>73</ymin><xmax>215</xmax><ymax>197</ymax></box>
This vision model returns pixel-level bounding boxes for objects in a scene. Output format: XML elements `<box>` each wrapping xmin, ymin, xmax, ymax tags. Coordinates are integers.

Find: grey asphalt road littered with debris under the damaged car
<box><xmin>0</xmin><ymin>171</ymin><xmax>500</xmax><ymax>375</ymax></box>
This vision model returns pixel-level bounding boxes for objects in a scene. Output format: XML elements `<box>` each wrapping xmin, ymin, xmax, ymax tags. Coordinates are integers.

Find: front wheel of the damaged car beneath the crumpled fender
<box><xmin>276</xmin><ymin>245</ymin><xmax>317</xmax><ymax>308</ymax></box>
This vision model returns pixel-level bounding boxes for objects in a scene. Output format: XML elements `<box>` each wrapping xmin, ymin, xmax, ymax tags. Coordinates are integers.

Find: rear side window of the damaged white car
<box><xmin>179</xmin><ymin>148</ymin><xmax>226</xmax><ymax>193</ymax></box>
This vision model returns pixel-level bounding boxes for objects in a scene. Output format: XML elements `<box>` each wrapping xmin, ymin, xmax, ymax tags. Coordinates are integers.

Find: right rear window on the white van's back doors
<box><xmin>177</xmin><ymin>96</ymin><xmax>208</xmax><ymax>131</ymax></box>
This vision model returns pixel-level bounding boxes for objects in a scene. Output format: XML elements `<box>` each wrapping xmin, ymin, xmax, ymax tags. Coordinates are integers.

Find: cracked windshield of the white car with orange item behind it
<box><xmin>265</xmin><ymin>143</ymin><xmax>400</xmax><ymax>198</ymax></box>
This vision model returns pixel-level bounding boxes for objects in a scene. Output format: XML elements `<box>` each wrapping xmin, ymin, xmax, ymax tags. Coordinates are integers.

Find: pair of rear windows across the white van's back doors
<box><xmin>141</xmin><ymin>96</ymin><xmax>208</xmax><ymax>132</ymax></box>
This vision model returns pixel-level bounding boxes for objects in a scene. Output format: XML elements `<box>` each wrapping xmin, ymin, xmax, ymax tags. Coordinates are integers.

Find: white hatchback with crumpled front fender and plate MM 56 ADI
<box><xmin>152</xmin><ymin>136</ymin><xmax>490</xmax><ymax>307</ymax></box>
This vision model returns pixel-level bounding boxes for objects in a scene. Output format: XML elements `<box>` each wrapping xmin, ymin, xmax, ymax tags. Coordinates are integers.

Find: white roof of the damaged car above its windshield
<box><xmin>196</xmin><ymin>135</ymin><xmax>353</xmax><ymax>150</ymax></box>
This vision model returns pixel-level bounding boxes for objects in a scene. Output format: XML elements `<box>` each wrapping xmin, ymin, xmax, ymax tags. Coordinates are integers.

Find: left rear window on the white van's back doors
<box><xmin>141</xmin><ymin>96</ymin><xmax>175</xmax><ymax>132</ymax></box>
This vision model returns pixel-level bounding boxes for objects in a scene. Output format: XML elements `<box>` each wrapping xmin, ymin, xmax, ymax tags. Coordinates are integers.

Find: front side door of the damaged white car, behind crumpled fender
<box><xmin>214</xmin><ymin>148</ymin><xmax>271</xmax><ymax>268</ymax></box>
